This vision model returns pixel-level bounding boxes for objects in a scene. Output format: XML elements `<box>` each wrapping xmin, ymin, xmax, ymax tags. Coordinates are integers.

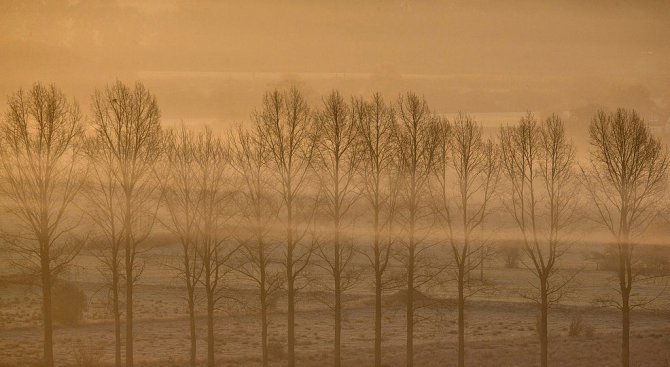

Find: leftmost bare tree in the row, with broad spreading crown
<box><xmin>0</xmin><ymin>84</ymin><xmax>84</xmax><ymax>367</ymax></box>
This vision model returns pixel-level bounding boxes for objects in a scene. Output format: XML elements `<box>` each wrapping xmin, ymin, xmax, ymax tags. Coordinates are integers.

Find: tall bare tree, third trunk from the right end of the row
<box><xmin>433</xmin><ymin>113</ymin><xmax>498</xmax><ymax>367</ymax></box>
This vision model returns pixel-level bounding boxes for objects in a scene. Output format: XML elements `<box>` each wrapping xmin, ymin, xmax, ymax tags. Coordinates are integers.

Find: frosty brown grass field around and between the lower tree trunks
<box><xmin>0</xmin><ymin>250</ymin><xmax>670</xmax><ymax>367</ymax></box>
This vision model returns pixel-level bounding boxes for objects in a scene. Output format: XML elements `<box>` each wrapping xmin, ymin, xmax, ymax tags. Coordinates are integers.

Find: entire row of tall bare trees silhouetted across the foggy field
<box><xmin>0</xmin><ymin>81</ymin><xmax>668</xmax><ymax>367</ymax></box>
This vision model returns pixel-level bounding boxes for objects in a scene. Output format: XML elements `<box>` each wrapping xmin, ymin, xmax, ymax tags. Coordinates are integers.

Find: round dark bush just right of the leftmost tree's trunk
<box><xmin>51</xmin><ymin>280</ymin><xmax>87</xmax><ymax>326</ymax></box>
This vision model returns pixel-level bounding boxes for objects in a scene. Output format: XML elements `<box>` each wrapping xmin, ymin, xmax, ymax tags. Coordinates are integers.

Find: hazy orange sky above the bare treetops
<box><xmin>0</xmin><ymin>0</ymin><xmax>670</xmax><ymax>126</ymax></box>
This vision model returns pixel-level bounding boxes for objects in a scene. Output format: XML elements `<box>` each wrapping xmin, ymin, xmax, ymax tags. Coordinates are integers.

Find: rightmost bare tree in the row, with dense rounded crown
<box><xmin>582</xmin><ymin>108</ymin><xmax>668</xmax><ymax>367</ymax></box>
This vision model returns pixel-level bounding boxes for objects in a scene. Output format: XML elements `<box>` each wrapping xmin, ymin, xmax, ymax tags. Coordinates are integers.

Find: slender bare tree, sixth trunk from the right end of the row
<box><xmin>314</xmin><ymin>91</ymin><xmax>359</xmax><ymax>367</ymax></box>
